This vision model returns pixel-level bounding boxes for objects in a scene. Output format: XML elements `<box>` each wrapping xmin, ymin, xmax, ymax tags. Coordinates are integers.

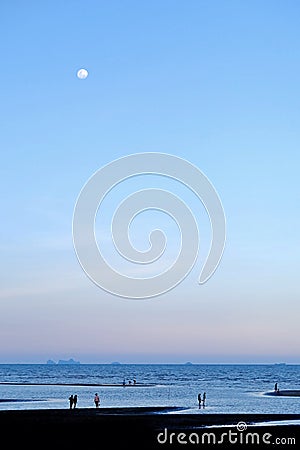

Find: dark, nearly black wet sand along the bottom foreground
<box><xmin>0</xmin><ymin>407</ymin><xmax>300</xmax><ymax>450</ymax></box>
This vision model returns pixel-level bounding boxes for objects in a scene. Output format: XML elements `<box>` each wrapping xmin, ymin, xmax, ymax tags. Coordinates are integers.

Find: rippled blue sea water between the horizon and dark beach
<box><xmin>0</xmin><ymin>364</ymin><xmax>300</xmax><ymax>414</ymax></box>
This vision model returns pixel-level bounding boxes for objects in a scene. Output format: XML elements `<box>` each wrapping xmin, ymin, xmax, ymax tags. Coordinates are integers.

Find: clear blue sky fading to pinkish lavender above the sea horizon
<box><xmin>0</xmin><ymin>0</ymin><xmax>300</xmax><ymax>363</ymax></box>
